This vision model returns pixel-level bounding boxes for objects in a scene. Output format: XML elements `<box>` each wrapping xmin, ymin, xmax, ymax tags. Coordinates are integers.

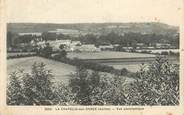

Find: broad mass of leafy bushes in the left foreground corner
<box><xmin>7</xmin><ymin>63</ymin><xmax>72</xmax><ymax>105</ymax></box>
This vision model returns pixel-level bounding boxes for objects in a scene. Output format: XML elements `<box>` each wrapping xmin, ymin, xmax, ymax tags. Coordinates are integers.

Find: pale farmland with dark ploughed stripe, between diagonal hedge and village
<box><xmin>68</xmin><ymin>51</ymin><xmax>179</xmax><ymax>72</ymax></box>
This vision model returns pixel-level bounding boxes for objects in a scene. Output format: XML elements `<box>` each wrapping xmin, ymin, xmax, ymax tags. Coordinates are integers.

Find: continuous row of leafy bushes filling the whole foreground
<box><xmin>7</xmin><ymin>57</ymin><xmax>179</xmax><ymax>105</ymax></box>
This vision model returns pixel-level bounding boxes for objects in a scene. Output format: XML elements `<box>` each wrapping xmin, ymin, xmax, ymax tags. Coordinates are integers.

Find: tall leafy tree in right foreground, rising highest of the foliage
<box><xmin>127</xmin><ymin>56</ymin><xmax>179</xmax><ymax>105</ymax></box>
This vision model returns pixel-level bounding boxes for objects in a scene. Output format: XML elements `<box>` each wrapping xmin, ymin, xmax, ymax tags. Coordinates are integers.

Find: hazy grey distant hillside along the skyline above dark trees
<box><xmin>7</xmin><ymin>23</ymin><xmax>179</xmax><ymax>34</ymax></box>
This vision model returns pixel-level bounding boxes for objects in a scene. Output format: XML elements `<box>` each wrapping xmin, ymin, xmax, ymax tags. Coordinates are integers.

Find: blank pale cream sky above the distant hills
<box><xmin>6</xmin><ymin>0</ymin><xmax>182</xmax><ymax>26</ymax></box>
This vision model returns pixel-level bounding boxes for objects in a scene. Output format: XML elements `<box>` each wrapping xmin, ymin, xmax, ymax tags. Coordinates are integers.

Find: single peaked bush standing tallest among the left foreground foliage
<box><xmin>23</xmin><ymin>63</ymin><xmax>55</xmax><ymax>105</ymax></box>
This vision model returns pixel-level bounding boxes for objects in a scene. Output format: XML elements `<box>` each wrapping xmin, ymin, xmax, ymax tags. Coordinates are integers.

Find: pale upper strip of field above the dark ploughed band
<box><xmin>67</xmin><ymin>51</ymin><xmax>155</xmax><ymax>59</ymax></box>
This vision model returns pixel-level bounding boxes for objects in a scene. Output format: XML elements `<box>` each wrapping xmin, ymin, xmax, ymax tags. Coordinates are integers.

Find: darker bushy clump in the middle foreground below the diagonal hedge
<box><xmin>69</xmin><ymin>67</ymin><xmax>126</xmax><ymax>105</ymax></box>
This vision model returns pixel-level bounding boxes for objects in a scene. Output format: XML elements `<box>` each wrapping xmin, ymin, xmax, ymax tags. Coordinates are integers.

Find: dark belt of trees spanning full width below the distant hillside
<box><xmin>7</xmin><ymin>32</ymin><xmax>179</xmax><ymax>48</ymax></box>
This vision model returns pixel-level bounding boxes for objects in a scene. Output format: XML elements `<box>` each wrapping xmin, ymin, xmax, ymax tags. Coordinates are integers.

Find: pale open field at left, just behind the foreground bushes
<box><xmin>7</xmin><ymin>57</ymin><xmax>76</xmax><ymax>83</ymax></box>
